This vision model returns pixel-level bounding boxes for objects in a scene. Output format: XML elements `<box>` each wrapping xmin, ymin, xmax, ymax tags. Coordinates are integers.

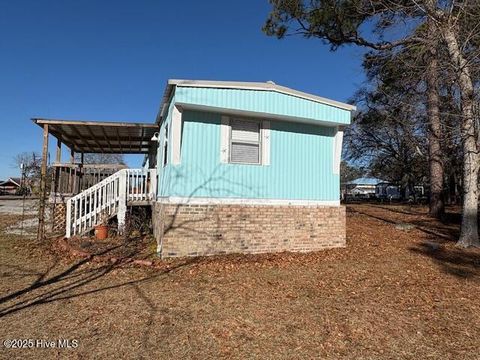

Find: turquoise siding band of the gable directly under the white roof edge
<box><xmin>175</xmin><ymin>86</ymin><xmax>351</xmax><ymax>124</ymax></box>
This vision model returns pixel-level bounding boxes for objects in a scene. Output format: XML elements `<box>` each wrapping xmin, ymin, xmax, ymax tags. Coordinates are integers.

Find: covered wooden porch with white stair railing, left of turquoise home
<box><xmin>32</xmin><ymin>118</ymin><xmax>158</xmax><ymax>239</ymax></box>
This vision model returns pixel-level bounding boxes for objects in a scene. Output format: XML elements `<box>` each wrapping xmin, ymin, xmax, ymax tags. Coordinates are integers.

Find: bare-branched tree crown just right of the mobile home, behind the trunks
<box><xmin>345</xmin><ymin>86</ymin><xmax>428</xmax><ymax>192</ymax></box>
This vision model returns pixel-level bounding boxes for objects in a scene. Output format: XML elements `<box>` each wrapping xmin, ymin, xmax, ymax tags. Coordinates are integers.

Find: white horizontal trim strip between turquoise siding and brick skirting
<box><xmin>157</xmin><ymin>196</ymin><xmax>340</xmax><ymax>207</ymax></box>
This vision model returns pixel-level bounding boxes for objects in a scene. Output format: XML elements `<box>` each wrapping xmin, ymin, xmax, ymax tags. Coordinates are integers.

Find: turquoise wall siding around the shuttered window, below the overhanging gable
<box><xmin>158</xmin><ymin>109</ymin><xmax>341</xmax><ymax>200</ymax></box>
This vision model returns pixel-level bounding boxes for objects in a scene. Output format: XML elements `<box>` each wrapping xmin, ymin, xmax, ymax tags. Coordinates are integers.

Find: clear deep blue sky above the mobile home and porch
<box><xmin>0</xmin><ymin>0</ymin><xmax>364</xmax><ymax>179</ymax></box>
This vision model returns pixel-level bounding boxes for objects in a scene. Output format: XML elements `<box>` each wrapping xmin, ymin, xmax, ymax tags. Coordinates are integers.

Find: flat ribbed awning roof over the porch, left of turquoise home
<box><xmin>32</xmin><ymin>118</ymin><xmax>158</xmax><ymax>154</ymax></box>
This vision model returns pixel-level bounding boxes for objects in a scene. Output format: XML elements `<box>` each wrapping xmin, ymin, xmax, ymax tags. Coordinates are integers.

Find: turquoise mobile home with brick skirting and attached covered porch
<box><xmin>34</xmin><ymin>80</ymin><xmax>355</xmax><ymax>257</ymax></box>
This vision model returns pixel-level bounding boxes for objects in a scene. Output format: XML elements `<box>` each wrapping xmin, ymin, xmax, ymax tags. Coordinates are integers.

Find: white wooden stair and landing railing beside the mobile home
<box><xmin>66</xmin><ymin>169</ymin><xmax>157</xmax><ymax>238</ymax></box>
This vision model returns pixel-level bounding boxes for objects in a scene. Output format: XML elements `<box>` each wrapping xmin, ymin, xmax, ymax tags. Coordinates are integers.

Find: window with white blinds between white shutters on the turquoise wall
<box><xmin>229</xmin><ymin>119</ymin><xmax>261</xmax><ymax>164</ymax></box>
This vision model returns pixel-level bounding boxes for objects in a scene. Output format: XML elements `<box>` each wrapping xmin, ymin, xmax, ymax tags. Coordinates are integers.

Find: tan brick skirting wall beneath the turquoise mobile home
<box><xmin>152</xmin><ymin>203</ymin><xmax>346</xmax><ymax>257</ymax></box>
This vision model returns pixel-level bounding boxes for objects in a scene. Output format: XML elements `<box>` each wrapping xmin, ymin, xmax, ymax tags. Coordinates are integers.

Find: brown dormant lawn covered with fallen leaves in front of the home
<box><xmin>0</xmin><ymin>205</ymin><xmax>480</xmax><ymax>359</ymax></box>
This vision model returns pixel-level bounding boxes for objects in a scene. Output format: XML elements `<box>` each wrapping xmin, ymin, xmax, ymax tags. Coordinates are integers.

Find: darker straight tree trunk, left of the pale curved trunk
<box><xmin>426</xmin><ymin>21</ymin><xmax>445</xmax><ymax>219</ymax></box>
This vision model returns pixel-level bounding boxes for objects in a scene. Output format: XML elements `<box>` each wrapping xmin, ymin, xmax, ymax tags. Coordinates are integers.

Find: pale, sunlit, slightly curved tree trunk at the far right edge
<box><xmin>442</xmin><ymin>24</ymin><xmax>480</xmax><ymax>247</ymax></box>
